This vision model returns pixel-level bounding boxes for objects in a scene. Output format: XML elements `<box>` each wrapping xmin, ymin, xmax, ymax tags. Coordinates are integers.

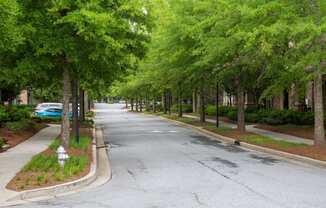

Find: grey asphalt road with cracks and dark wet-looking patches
<box><xmin>14</xmin><ymin>104</ymin><xmax>326</xmax><ymax>208</ymax></box>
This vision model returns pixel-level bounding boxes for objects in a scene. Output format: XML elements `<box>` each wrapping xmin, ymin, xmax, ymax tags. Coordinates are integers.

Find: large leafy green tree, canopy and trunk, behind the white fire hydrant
<box><xmin>21</xmin><ymin>0</ymin><xmax>152</xmax><ymax>147</ymax></box>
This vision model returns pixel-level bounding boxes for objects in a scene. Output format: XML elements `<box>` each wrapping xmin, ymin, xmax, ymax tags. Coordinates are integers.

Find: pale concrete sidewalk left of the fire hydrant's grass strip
<box><xmin>0</xmin><ymin>125</ymin><xmax>60</xmax><ymax>205</ymax></box>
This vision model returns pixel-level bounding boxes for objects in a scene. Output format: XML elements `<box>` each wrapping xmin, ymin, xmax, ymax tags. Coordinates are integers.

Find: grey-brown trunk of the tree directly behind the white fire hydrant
<box><xmin>61</xmin><ymin>67</ymin><xmax>71</xmax><ymax>148</ymax></box>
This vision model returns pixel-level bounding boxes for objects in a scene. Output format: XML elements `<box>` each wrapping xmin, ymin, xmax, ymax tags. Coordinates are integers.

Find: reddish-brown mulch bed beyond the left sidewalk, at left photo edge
<box><xmin>0</xmin><ymin>123</ymin><xmax>47</xmax><ymax>152</ymax></box>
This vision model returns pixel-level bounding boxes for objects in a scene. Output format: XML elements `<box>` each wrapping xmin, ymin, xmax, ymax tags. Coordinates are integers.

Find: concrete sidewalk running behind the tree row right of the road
<box><xmin>183</xmin><ymin>115</ymin><xmax>313</xmax><ymax>145</ymax></box>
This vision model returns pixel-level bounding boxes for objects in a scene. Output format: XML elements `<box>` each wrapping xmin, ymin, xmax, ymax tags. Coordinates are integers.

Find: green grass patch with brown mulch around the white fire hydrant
<box><xmin>14</xmin><ymin>136</ymin><xmax>91</xmax><ymax>190</ymax></box>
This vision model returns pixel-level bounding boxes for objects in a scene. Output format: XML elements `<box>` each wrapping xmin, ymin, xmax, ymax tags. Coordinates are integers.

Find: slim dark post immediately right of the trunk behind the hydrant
<box><xmin>72</xmin><ymin>78</ymin><xmax>79</xmax><ymax>143</ymax></box>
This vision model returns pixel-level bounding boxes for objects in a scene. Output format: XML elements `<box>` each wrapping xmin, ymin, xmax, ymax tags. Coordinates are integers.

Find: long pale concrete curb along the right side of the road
<box><xmin>159</xmin><ymin>116</ymin><xmax>326</xmax><ymax>168</ymax></box>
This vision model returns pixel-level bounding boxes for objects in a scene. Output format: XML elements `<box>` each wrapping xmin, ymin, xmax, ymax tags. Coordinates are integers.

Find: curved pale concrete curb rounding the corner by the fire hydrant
<box><xmin>0</xmin><ymin>128</ymin><xmax>112</xmax><ymax>207</ymax></box>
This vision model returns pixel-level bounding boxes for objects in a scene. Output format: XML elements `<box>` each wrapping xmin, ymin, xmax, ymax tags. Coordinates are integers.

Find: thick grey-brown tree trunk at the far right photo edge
<box><xmin>314</xmin><ymin>75</ymin><xmax>326</xmax><ymax>145</ymax></box>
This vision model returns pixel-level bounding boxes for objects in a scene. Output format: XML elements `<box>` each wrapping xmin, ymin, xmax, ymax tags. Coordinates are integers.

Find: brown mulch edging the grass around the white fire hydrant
<box><xmin>6</xmin><ymin>128</ymin><xmax>93</xmax><ymax>191</ymax></box>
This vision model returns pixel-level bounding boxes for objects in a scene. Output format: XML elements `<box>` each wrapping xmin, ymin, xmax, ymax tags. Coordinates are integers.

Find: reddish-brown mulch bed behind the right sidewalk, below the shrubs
<box><xmin>255</xmin><ymin>124</ymin><xmax>314</xmax><ymax>140</ymax></box>
